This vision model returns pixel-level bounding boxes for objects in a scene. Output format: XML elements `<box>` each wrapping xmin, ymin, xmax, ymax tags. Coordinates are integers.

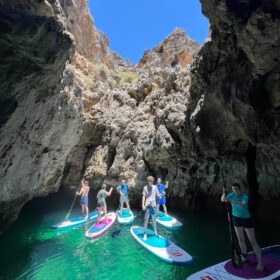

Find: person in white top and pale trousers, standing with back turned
<box><xmin>142</xmin><ymin>176</ymin><xmax>160</xmax><ymax>240</ymax></box>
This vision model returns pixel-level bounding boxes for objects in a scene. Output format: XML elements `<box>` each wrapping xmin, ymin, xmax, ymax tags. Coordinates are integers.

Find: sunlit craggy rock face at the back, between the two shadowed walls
<box><xmin>63</xmin><ymin>29</ymin><xmax>199</xmax><ymax>202</ymax></box>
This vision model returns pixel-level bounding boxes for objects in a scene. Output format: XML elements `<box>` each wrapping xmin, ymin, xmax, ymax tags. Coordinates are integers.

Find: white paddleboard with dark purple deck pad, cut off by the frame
<box><xmin>187</xmin><ymin>245</ymin><xmax>280</xmax><ymax>280</ymax></box>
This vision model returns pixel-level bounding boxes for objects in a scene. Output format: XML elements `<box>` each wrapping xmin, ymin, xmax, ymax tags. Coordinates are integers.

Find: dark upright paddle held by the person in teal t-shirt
<box><xmin>222</xmin><ymin>166</ymin><xmax>243</xmax><ymax>268</ymax></box>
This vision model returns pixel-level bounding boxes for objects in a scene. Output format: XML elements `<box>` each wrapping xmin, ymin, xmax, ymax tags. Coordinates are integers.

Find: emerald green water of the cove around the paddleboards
<box><xmin>0</xmin><ymin>202</ymin><xmax>280</xmax><ymax>280</ymax></box>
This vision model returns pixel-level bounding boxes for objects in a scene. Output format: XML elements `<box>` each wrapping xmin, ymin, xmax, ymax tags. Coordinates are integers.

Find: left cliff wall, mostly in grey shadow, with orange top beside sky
<box><xmin>0</xmin><ymin>0</ymin><xmax>113</xmax><ymax>231</ymax></box>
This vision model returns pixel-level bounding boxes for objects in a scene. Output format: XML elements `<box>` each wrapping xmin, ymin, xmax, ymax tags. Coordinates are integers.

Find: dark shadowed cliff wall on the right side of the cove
<box><xmin>186</xmin><ymin>0</ymin><xmax>280</xmax><ymax>219</ymax></box>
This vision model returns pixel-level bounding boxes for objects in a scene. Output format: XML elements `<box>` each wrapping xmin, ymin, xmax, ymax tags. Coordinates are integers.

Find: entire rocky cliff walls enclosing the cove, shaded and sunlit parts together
<box><xmin>0</xmin><ymin>0</ymin><xmax>280</xmax><ymax>232</ymax></box>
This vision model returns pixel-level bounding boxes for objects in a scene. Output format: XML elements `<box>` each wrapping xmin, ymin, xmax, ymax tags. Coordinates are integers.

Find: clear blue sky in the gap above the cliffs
<box><xmin>88</xmin><ymin>0</ymin><xmax>208</xmax><ymax>63</ymax></box>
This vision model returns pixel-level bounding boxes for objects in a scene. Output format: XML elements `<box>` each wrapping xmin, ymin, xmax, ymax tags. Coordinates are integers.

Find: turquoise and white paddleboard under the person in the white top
<box><xmin>130</xmin><ymin>226</ymin><xmax>192</xmax><ymax>265</ymax></box>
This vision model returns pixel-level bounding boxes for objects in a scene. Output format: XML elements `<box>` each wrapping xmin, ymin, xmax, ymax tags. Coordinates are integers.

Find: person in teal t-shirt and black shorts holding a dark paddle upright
<box><xmin>221</xmin><ymin>183</ymin><xmax>264</xmax><ymax>271</ymax></box>
